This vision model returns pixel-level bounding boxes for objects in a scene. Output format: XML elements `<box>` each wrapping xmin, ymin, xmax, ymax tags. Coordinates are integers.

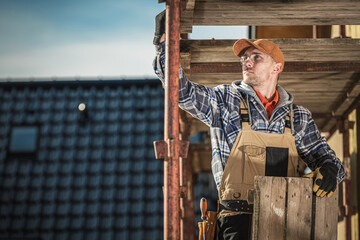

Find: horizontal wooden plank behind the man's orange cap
<box><xmin>181</xmin><ymin>39</ymin><xmax>360</xmax><ymax>63</ymax></box>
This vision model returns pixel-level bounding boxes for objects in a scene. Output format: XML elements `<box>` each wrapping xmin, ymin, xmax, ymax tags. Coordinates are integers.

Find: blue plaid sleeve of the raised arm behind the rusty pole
<box><xmin>153</xmin><ymin>42</ymin><xmax>217</xmax><ymax>126</ymax></box>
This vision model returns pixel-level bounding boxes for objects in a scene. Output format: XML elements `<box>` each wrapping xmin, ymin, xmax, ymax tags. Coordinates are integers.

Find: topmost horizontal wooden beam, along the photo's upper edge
<box><xmin>194</xmin><ymin>0</ymin><xmax>360</xmax><ymax>26</ymax></box>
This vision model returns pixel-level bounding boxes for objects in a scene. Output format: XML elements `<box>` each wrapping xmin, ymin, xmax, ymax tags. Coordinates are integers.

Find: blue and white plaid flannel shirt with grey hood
<box><xmin>153</xmin><ymin>43</ymin><xmax>345</xmax><ymax>187</ymax></box>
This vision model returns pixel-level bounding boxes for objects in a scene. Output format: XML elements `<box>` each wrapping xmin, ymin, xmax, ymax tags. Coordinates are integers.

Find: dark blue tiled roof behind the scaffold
<box><xmin>0</xmin><ymin>80</ymin><xmax>164</xmax><ymax>240</ymax></box>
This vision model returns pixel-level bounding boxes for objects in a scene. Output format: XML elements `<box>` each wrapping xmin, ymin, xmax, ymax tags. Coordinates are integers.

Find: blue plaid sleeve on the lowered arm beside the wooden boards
<box><xmin>295</xmin><ymin>106</ymin><xmax>345</xmax><ymax>183</ymax></box>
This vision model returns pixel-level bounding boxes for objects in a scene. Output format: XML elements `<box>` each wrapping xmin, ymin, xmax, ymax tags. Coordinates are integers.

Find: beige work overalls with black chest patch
<box><xmin>218</xmin><ymin>101</ymin><xmax>298</xmax><ymax>218</ymax></box>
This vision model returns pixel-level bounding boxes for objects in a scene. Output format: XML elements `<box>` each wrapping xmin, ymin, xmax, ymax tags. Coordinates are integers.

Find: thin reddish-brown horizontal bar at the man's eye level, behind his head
<box><xmin>186</xmin><ymin>61</ymin><xmax>360</xmax><ymax>74</ymax></box>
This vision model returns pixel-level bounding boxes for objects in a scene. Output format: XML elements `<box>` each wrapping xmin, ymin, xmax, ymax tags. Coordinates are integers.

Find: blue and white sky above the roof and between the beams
<box><xmin>0</xmin><ymin>0</ymin><xmax>247</xmax><ymax>81</ymax></box>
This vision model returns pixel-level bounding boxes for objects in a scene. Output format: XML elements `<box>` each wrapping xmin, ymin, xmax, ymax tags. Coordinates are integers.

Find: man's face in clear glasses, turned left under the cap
<box><xmin>242</xmin><ymin>47</ymin><xmax>276</xmax><ymax>87</ymax></box>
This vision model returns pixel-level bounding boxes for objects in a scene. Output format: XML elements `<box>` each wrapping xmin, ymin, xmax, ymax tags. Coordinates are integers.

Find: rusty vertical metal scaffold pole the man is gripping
<box><xmin>164</xmin><ymin>0</ymin><xmax>180</xmax><ymax>240</ymax></box>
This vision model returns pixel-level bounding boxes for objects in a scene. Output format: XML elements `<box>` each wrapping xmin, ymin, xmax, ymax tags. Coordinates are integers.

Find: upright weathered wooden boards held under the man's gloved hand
<box><xmin>252</xmin><ymin>176</ymin><xmax>338</xmax><ymax>240</ymax></box>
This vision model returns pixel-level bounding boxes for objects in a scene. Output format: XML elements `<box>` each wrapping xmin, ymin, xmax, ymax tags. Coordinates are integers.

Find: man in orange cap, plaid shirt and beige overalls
<box><xmin>154</xmin><ymin>12</ymin><xmax>345</xmax><ymax>240</ymax></box>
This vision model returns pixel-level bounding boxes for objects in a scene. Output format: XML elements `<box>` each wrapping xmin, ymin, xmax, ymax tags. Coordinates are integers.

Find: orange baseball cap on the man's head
<box><xmin>233</xmin><ymin>39</ymin><xmax>285</xmax><ymax>71</ymax></box>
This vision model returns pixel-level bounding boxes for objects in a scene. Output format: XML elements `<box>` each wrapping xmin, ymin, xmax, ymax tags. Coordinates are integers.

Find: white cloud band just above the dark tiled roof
<box><xmin>0</xmin><ymin>40</ymin><xmax>155</xmax><ymax>78</ymax></box>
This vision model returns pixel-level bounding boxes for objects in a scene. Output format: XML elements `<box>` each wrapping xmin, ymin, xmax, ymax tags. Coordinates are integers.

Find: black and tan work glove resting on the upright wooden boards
<box><xmin>304</xmin><ymin>163</ymin><xmax>338</xmax><ymax>197</ymax></box>
